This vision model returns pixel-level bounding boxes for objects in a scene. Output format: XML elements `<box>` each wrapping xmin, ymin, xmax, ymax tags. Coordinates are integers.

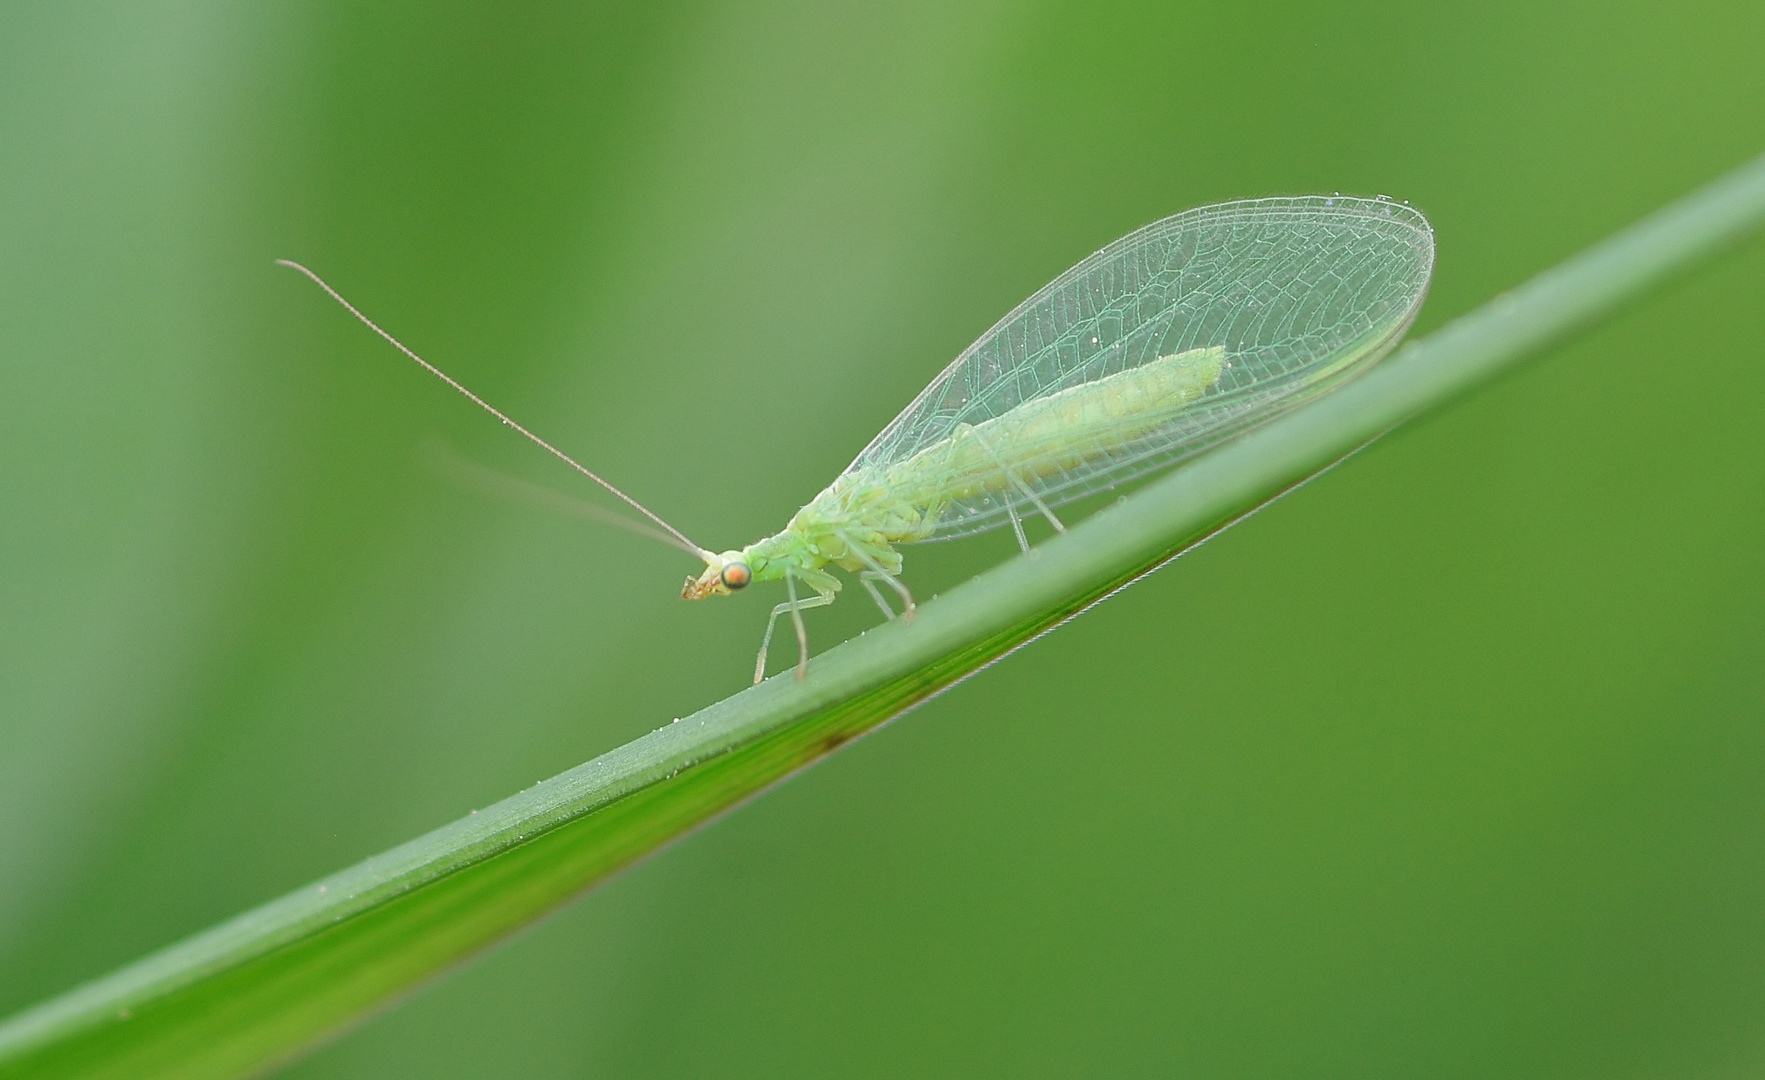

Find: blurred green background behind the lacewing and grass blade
<box><xmin>0</xmin><ymin>0</ymin><xmax>1765</xmax><ymax>1080</ymax></box>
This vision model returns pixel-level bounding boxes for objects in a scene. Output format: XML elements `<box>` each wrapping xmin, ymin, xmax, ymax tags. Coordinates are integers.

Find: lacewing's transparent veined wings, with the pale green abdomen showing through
<box><xmin>837</xmin><ymin>196</ymin><xmax>1433</xmax><ymax>540</ymax></box>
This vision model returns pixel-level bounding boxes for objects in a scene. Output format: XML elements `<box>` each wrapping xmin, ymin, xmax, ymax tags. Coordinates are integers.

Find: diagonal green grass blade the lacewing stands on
<box><xmin>10</xmin><ymin>157</ymin><xmax>1765</xmax><ymax>1080</ymax></box>
